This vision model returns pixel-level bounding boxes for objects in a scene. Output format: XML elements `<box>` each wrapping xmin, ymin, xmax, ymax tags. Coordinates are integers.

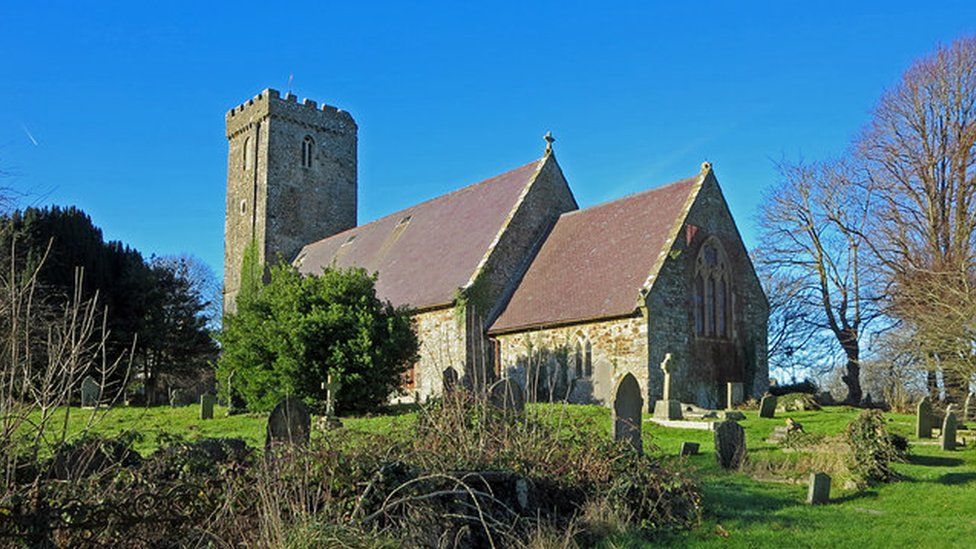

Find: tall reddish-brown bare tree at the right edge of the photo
<box><xmin>857</xmin><ymin>37</ymin><xmax>976</xmax><ymax>400</ymax></box>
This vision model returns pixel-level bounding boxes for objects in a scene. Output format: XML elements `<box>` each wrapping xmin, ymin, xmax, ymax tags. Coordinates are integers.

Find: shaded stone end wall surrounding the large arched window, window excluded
<box><xmin>646</xmin><ymin>173</ymin><xmax>769</xmax><ymax>408</ymax></box>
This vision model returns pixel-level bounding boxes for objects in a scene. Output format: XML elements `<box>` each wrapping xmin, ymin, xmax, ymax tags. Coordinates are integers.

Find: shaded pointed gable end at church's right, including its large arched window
<box><xmin>646</xmin><ymin>170</ymin><xmax>768</xmax><ymax>407</ymax></box>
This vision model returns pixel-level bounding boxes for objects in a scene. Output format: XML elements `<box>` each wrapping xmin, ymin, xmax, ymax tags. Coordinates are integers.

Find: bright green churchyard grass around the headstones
<box><xmin>36</xmin><ymin>404</ymin><xmax>976</xmax><ymax>547</ymax></box>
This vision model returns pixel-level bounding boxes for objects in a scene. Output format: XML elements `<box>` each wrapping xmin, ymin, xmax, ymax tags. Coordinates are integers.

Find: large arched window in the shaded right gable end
<box><xmin>692</xmin><ymin>238</ymin><xmax>732</xmax><ymax>338</ymax></box>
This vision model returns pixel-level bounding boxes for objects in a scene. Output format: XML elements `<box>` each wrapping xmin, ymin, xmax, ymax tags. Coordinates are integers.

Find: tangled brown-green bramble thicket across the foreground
<box><xmin>0</xmin><ymin>393</ymin><xmax>701</xmax><ymax>547</ymax></box>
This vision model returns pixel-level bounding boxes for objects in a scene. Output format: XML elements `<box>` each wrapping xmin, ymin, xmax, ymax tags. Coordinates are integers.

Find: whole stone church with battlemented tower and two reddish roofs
<box><xmin>224</xmin><ymin>89</ymin><xmax>769</xmax><ymax>409</ymax></box>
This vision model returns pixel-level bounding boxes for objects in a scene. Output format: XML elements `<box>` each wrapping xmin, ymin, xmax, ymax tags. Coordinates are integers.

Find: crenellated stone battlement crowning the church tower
<box><xmin>225</xmin><ymin>88</ymin><xmax>356</xmax><ymax>137</ymax></box>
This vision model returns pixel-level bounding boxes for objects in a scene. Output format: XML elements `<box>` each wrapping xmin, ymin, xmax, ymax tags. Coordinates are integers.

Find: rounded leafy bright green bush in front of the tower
<box><xmin>218</xmin><ymin>264</ymin><xmax>419</xmax><ymax>412</ymax></box>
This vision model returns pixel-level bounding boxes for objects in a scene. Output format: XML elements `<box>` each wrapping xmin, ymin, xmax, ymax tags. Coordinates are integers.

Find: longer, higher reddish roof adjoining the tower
<box><xmin>296</xmin><ymin>160</ymin><xmax>542</xmax><ymax>308</ymax></box>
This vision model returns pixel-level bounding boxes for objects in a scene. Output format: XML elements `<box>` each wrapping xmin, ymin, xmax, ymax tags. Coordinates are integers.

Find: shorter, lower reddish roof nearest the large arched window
<box><xmin>491</xmin><ymin>175</ymin><xmax>702</xmax><ymax>332</ymax></box>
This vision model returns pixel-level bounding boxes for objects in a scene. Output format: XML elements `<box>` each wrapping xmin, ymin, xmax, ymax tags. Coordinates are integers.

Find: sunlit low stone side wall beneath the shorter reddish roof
<box><xmin>496</xmin><ymin>314</ymin><xmax>649</xmax><ymax>405</ymax></box>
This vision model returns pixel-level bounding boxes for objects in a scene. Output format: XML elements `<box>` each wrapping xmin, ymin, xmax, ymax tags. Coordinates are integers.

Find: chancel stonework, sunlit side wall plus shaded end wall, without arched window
<box><xmin>496</xmin><ymin>170</ymin><xmax>769</xmax><ymax>413</ymax></box>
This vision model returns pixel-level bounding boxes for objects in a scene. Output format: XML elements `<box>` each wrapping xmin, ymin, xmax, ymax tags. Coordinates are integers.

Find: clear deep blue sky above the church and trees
<box><xmin>0</xmin><ymin>0</ymin><xmax>976</xmax><ymax>273</ymax></box>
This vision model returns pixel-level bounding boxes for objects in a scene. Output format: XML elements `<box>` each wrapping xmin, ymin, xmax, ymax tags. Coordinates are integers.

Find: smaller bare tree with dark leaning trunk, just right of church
<box><xmin>757</xmin><ymin>158</ymin><xmax>879</xmax><ymax>403</ymax></box>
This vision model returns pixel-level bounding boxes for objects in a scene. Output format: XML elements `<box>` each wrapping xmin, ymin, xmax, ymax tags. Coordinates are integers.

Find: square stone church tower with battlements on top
<box><xmin>224</xmin><ymin>89</ymin><xmax>357</xmax><ymax>313</ymax></box>
